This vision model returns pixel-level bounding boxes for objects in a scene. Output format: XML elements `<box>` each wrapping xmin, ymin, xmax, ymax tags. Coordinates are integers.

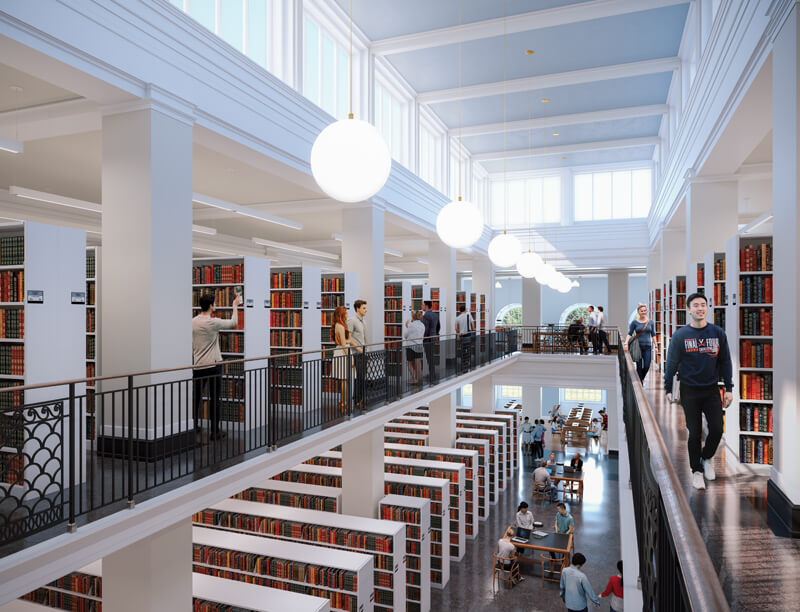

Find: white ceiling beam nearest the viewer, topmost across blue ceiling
<box><xmin>370</xmin><ymin>0</ymin><xmax>691</xmax><ymax>55</ymax></box>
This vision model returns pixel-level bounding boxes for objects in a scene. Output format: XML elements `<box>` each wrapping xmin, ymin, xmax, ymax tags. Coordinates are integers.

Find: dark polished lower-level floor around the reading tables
<box><xmin>431</xmin><ymin>446</ymin><xmax>620</xmax><ymax>612</ymax></box>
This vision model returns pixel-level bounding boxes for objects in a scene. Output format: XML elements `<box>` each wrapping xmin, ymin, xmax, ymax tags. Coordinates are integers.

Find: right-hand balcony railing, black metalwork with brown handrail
<box><xmin>619</xmin><ymin>351</ymin><xmax>730</xmax><ymax>612</ymax></box>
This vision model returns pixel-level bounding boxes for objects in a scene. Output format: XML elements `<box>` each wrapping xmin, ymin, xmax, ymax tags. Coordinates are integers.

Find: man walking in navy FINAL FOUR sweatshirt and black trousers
<box><xmin>664</xmin><ymin>293</ymin><xmax>733</xmax><ymax>489</ymax></box>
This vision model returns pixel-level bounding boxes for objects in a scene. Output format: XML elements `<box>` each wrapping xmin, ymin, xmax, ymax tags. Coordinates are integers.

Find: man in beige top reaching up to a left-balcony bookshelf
<box><xmin>192</xmin><ymin>292</ymin><xmax>242</xmax><ymax>444</ymax></box>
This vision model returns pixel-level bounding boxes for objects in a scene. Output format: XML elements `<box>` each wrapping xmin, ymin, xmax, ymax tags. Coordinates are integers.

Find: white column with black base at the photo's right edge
<box><xmin>767</xmin><ymin>5</ymin><xmax>800</xmax><ymax>537</ymax></box>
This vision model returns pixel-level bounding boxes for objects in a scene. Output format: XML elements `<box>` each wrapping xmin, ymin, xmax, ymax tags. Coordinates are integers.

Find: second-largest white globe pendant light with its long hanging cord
<box><xmin>436</xmin><ymin>2</ymin><xmax>483</xmax><ymax>249</ymax></box>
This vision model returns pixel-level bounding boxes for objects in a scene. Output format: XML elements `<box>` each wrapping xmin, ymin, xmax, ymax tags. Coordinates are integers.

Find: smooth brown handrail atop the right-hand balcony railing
<box><xmin>624</xmin><ymin>351</ymin><xmax>730</xmax><ymax>612</ymax></box>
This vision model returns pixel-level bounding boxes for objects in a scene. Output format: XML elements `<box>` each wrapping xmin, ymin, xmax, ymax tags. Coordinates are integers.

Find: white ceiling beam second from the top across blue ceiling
<box><xmin>417</xmin><ymin>57</ymin><xmax>681</xmax><ymax>104</ymax></box>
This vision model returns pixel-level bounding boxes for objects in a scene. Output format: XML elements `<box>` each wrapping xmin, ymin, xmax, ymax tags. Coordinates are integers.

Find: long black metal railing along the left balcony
<box><xmin>0</xmin><ymin>330</ymin><xmax>517</xmax><ymax>555</ymax></box>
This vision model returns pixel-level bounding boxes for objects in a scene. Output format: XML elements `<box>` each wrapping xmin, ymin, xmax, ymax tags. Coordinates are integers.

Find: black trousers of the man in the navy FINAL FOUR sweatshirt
<box><xmin>681</xmin><ymin>383</ymin><xmax>722</xmax><ymax>472</ymax></box>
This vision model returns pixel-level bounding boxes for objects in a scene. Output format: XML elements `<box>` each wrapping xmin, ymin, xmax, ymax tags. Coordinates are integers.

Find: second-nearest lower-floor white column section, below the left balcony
<box><xmin>342</xmin><ymin>426</ymin><xmax>384</xmax><ymax>518</ymax></box>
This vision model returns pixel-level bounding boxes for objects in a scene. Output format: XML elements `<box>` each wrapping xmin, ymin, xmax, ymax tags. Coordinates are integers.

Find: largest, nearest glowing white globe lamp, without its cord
<box><xmin>311</xmin><ymin>118</ymin><xmax>392</xmax><ymax>202</ymax></box>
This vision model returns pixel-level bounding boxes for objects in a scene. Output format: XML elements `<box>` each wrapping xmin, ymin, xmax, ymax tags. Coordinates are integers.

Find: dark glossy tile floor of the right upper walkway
<box><xmin>645</xmin><ymin>376</ymin><xmax>800</xmax><ymax>612</ymax></box>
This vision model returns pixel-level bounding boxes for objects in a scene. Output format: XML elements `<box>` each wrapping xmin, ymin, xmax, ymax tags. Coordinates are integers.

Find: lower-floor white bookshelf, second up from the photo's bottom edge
<box><xmin>192</xmin><ymin>515</ymin><xmax>373</xmax><ymax>612</ymax></box>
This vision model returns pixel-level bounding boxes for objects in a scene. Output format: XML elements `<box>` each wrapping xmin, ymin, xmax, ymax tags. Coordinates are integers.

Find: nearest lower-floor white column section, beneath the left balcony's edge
<box><xmin>103</xmin><ymin>518</ymin><xmax>192</xmax><ymax>612</ymax></box>
